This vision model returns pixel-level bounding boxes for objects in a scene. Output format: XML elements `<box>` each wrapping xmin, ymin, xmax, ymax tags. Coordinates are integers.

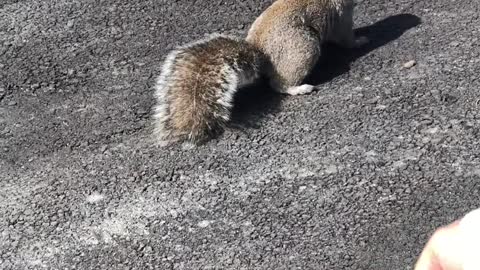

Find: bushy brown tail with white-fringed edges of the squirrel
<box><xmin>153</xmin><ymin>35</ymin><xmax>268</xmax><ymax>146</ymax></box>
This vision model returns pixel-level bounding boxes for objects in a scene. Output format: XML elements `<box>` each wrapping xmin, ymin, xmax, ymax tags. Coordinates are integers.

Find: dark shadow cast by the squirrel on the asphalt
<box><xmin>230</xmin><ymin>14</ymin><xmax>421</xmax><ymax>128</ymax></box>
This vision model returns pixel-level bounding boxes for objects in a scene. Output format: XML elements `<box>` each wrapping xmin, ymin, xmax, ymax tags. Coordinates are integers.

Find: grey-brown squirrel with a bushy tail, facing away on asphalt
<box><xmin>153</xmin><ymin>0</ymin><xmax>368</xmax><ymax>145</ymax></box>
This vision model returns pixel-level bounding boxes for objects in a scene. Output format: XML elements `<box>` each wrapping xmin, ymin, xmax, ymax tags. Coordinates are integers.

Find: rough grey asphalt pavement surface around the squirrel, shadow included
<box><xmin>0</xmin><ymin>0</ymin><xmax>480</xmax><ymax>269</ymax></box>
